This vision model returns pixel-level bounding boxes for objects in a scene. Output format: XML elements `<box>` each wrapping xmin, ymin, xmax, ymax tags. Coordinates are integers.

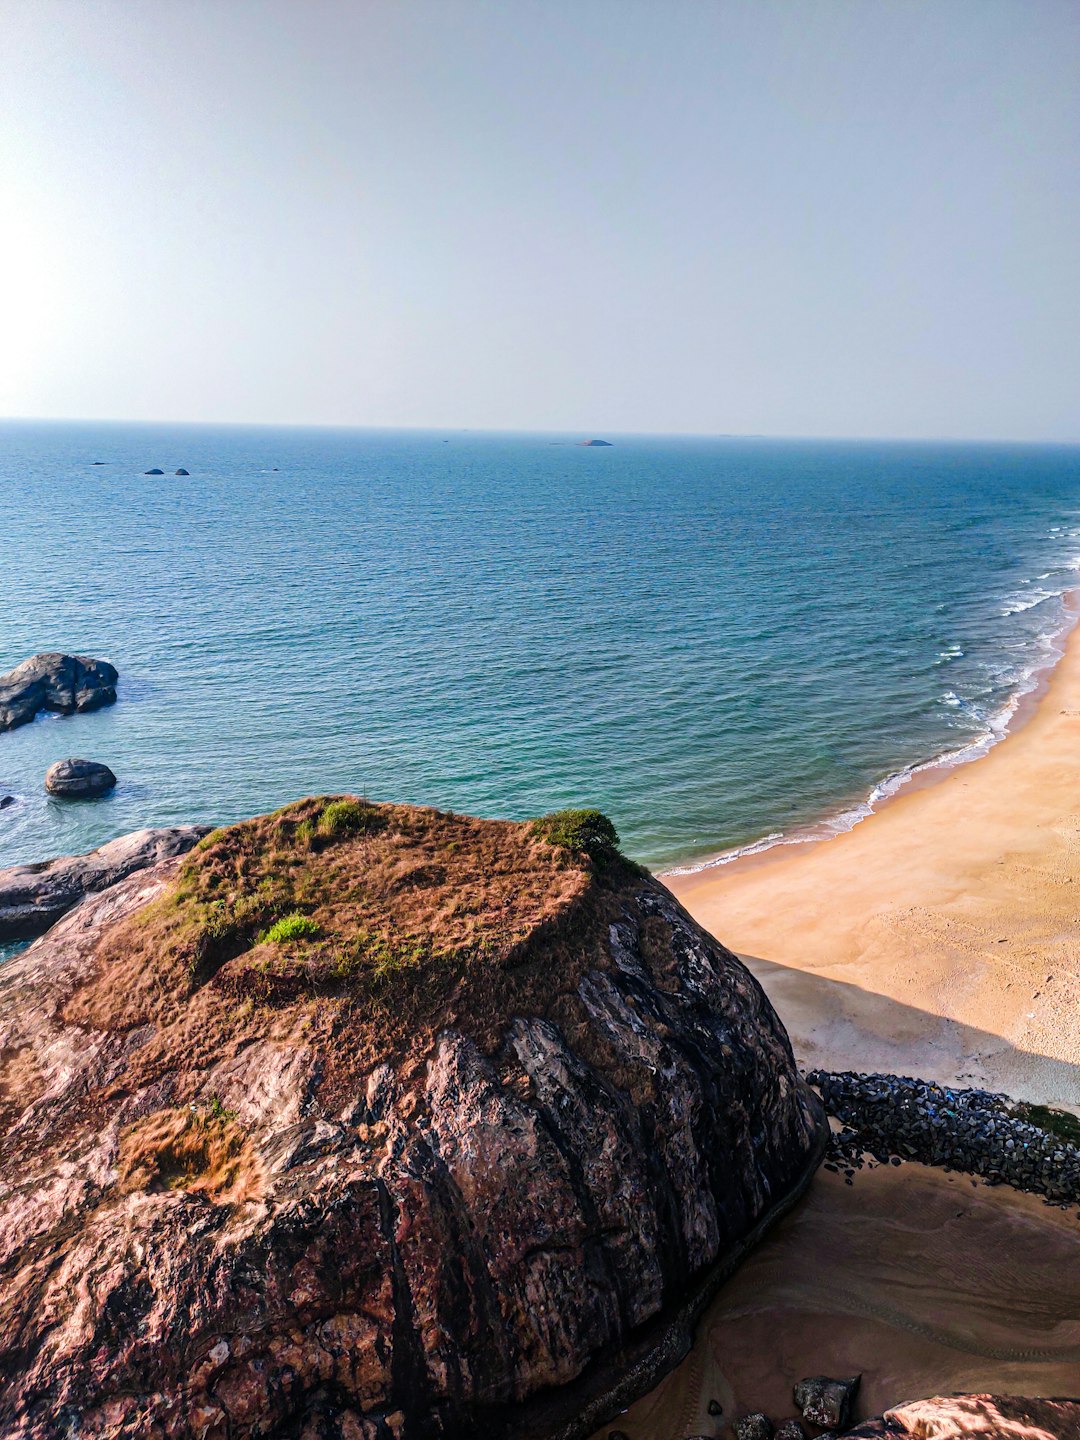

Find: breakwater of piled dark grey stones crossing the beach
<box><xmin>806</xmin><ymin>1070</ymin><xmax>1080</xmax><ymax>1205</ymax></box>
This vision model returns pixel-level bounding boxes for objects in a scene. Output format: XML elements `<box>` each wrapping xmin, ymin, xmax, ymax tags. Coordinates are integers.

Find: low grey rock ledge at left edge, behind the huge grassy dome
<box><xmin>0</xmin><ymin>825</ymin><xmax>210</xmax><ymax>940</ymax></box>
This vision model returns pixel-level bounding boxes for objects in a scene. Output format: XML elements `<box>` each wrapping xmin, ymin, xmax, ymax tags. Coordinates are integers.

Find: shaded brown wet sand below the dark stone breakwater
<box><xmin>598</xmin><ymin>1165</ymin><xmax>1080</xmax><ymax>1440</ymax></box>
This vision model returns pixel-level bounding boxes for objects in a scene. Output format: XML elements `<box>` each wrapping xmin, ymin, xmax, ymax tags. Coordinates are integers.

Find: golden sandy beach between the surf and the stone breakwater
<box><xmin>664</xmin><ymin>601</ymin><xmax>1080</xmax><ymax>1107</ymax></box>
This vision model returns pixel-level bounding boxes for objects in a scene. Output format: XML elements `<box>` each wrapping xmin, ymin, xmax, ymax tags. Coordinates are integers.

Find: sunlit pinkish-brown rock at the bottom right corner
<box><xmin>845</xmin><ymin>1395</ymin><xmax>1080</xmax><ymax>1440</ymax></box>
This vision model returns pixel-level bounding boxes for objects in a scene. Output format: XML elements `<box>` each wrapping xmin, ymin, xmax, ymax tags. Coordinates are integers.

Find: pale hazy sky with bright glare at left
<box><xmin>0</xmin><ymin>0</ymin><xmax>1080</xmax><ymax>439</ymax></box>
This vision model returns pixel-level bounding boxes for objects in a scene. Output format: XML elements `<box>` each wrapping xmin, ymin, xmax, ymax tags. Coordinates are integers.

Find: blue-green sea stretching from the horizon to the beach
<box><xmin>0</xmin><ymin>422</ymin><xmax>1080</xmax><ymax>867</ymax></box>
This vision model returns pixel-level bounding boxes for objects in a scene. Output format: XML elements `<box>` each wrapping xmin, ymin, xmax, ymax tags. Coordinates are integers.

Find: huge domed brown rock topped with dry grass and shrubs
<box><xmin>0</xmin><ymin>799</ymin><xmax>825</xmax><ymax>1440</ymax></box>
